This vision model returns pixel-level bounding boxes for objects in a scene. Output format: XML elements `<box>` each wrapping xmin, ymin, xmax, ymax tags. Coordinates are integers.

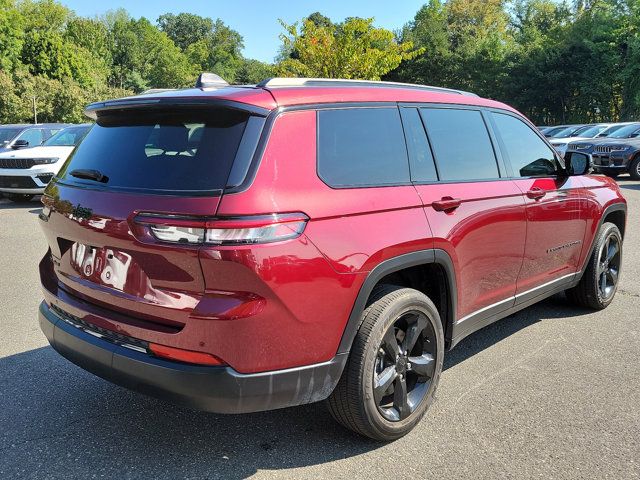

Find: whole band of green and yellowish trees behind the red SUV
<box><xmin>0</xmin><ymin>0</ymin><xmax>640</xmax><ymax>124</ymax></box>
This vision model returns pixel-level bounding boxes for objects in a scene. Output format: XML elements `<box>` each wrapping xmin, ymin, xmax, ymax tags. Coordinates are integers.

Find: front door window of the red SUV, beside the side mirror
<box><xmin>491</xmin><ymin>112</ymin><xmax>558</xmax><ymax>177</ymax></box>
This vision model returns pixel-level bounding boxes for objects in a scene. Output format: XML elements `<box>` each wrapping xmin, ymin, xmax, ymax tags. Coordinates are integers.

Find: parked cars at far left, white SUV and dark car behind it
<box><xmin>0</xmin><ymin>123</ymin><xmax>91</xmax><ymax>201</ymax></box>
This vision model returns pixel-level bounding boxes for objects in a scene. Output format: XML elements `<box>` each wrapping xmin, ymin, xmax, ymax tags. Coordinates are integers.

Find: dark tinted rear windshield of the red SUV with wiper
<box><xmin>59</xmin><ymin>109</ymin><xmax>248</xmax><ymax>194</ymax></box>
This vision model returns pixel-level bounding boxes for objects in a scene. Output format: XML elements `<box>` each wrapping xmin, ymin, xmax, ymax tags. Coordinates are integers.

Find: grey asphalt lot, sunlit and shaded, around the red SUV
<box><xmin>0</xmin><ymin>178</ymin><xmax>640</xmax><ymax>479</ymax></box>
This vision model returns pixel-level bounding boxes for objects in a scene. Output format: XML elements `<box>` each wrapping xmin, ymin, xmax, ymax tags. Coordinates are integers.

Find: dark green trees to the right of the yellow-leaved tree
<box><xmin>387</xmin><ymin>0</ymin><xmax>640</xmax><ymax>124</ymax></box>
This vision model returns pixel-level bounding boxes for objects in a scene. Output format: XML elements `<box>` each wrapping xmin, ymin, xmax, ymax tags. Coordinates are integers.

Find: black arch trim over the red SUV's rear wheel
<box><xmin>337</xmin><ymin>249</ymin><xmax>458</xmax><ymax>354</ymax></box>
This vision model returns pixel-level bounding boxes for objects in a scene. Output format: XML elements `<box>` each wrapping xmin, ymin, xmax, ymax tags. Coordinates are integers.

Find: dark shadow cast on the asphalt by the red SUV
<box><xmin>0</xmin><ymin>298</ymin><xmax>583</xmax><ymax>478</ymax></box>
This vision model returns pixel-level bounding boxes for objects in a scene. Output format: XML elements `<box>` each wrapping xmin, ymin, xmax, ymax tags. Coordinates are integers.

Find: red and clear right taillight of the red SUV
<box><xmin>134</xmin><ymin>213</ymin><xmax>309</xmax><ymax>245</ymax></box>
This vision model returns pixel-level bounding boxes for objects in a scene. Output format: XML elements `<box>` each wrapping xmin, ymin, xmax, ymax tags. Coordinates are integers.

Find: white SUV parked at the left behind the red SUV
<box><xmin>0</xmin><ymin>124</ymin><xmax>91</xmax><ymax>202</ymax></box>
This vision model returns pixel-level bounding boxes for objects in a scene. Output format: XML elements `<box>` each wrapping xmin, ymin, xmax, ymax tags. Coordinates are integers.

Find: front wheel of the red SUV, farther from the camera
<box><xmin>566</xmin><ymin>222</ymin><xmax>622</xmax><ymax>310</ymax></box>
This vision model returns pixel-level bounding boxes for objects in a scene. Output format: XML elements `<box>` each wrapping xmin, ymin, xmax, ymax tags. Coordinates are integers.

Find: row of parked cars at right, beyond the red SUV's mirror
<box><xmin>538</xmin><ymin>122</ymin><xmax>640</xmax><ymax>180</ymax></box>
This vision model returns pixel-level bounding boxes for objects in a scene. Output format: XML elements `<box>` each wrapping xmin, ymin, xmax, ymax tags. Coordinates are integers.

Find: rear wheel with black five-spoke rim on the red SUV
<box><xmin>327</xmin><ymin>285</ymin><xmax>444</xmax><ymax>441</ymax></box>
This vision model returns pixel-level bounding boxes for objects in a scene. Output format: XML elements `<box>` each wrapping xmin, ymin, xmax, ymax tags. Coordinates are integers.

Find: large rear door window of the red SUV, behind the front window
<box><xmin>420</xmin><ymin>108</ymin><xmax>500</xmax><ymax>181</ymax></box>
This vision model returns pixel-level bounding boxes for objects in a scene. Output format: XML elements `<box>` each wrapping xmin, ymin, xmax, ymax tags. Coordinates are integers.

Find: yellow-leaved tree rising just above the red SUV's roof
<box><xmin>276</xmin><ymin>18</ymin><xmax>420</xmax><ymax>80</ymax></box>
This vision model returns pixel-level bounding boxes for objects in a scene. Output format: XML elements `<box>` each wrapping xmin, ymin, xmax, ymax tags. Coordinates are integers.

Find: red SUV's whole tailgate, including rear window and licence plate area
<box><xmin>41</xmin><ymin>101</ymin><xmax>262</xmax><ymax>331</ymax></box>
